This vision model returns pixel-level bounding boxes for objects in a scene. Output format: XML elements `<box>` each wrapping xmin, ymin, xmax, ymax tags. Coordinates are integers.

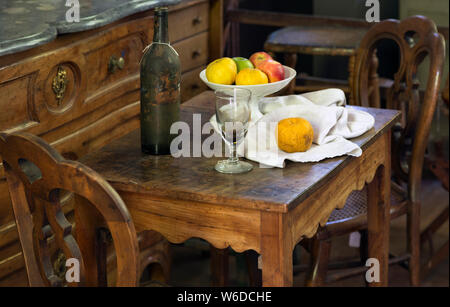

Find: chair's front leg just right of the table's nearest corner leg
<box><xmin>306</xmin><ymin>239</ymin><xmax>331</xmax><ymax>287</ymax></box>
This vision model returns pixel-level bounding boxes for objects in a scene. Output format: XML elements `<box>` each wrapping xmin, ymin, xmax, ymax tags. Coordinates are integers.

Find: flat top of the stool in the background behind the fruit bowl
<box><xmin>264</xmin><ymin>25</ymin><xmax>367</xmax><ymax>56</ymax></box>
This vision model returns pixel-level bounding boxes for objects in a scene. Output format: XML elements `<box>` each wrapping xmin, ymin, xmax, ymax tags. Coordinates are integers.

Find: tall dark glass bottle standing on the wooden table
<box><xmin>141</xmin><ymin>7</ymin><xmax>181</xmax><ymax>155</ymax></box>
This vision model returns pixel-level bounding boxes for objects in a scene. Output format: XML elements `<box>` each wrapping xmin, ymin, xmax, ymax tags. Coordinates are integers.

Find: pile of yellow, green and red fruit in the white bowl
<box><xmin>206</xmin><ymin>52</ymin><xmax>285</xmax><ymax>85</ymax></box>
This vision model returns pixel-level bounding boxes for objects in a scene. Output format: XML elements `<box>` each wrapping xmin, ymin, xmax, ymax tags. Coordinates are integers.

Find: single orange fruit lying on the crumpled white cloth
<box><xmin>277</xmin><ymin>117</ymin><xmax>314</xmax><ymax>153</ymax></box>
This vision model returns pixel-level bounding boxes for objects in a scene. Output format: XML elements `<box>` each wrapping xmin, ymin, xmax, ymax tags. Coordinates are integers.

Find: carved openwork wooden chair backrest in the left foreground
<box><xmin>0</xmin><ymin>133</ymin><xmax>139</xmax><ymax>286</ymax></box>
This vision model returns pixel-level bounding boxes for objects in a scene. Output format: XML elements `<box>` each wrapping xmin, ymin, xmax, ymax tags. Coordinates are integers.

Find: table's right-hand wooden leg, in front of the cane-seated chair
<box><xmin>367</xmin><ymin>133</ymin><xmax>391</xmax><ymax>287</ymax></box>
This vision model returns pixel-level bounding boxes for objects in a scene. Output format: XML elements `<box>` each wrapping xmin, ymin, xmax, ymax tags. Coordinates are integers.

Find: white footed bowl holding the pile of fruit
<box><xmin>200</xmin><ymin>65</ymin><xmax>297</xmax><ymax>113</ymax></box>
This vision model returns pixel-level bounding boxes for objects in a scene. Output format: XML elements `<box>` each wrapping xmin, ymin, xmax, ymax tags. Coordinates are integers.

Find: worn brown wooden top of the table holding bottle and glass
<box><xmin>81</xmin><ymin>91</ymin><xmax>400</xmax><ymax>212</ymax></box>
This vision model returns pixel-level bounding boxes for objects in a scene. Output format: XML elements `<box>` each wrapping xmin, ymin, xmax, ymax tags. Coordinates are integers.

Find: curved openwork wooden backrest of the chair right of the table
<box><xmin>353</xmin><ymin>16</ymin><xmax>445</xmax><ymax>202</ymax></box>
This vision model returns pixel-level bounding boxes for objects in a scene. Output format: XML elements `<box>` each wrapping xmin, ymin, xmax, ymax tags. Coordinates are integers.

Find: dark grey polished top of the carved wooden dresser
<box><xmin>0</xmin><ymin>0</ymin><xmax>181</xmax><ymax>56</ymax></box>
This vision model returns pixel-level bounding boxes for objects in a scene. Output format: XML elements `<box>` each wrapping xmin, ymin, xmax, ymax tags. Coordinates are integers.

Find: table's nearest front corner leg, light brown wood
<box><xmin>261</xmin><ymin>212</ymin><xmax>293</xmax><ymax>287</ymax></box>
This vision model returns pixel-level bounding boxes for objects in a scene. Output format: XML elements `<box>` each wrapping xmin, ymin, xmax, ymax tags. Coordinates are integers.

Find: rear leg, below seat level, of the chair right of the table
<box><xmin>407</xmin><ymin>203</ymin><xmax>420</xmax><ymax>287</ymax></box>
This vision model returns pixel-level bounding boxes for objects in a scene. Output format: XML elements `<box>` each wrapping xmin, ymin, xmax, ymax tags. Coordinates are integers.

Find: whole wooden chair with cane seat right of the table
<box><xmin>305</xmin><ymin>16</ymin><xmax>445</xmax><ymax>286</ymax></box>
